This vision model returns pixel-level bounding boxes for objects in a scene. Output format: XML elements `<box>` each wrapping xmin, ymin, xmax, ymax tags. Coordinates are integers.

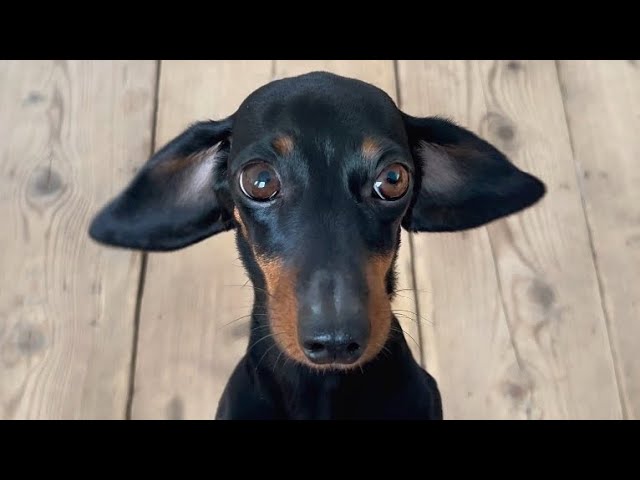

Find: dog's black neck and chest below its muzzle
<box><xmin>216</xmin><ymin>324</ymin><xmax>443</xmax><ymax>420</ymax></box>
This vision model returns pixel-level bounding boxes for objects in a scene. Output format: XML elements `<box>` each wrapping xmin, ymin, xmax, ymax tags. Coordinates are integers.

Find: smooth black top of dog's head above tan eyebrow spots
<box><xmin>233</xmin><ymin>72</ymin><xmax>406</xmax><ymax>144</ymax></box>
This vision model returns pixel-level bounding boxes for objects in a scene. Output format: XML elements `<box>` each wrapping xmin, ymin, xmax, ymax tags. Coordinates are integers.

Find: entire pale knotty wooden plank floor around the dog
<box><xmin>0</xmin><ymin>61</ymin><xmax>640</xmax><ymax>419</ymax></box>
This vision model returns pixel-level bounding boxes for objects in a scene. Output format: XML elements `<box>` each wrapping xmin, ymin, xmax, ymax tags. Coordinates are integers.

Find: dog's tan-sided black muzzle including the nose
<box><xmin>254</xmin><ymin>244</ymin><xmax>393</xmax><ymax>371</ymax></box>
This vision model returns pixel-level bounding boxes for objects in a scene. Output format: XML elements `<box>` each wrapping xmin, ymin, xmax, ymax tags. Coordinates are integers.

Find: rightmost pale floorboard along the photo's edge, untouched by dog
<box><xmin>558</xmin><ymin>60</ymin><xmax>640</xmax><ymax>419</ymax></box>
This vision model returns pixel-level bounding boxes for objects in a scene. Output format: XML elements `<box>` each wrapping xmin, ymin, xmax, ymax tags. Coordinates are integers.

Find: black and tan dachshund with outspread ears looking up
<box><xmin>89</xmin><ymin>72</ymin><xmax>546</xmax><ymax>420</ymax></box>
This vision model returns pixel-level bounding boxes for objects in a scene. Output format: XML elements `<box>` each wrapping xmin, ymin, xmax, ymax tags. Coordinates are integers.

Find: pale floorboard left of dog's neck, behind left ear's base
<box><xmin>132</xmin><ymin>61</ymin><xmax>272</xmax><ymax>419</ymax></box>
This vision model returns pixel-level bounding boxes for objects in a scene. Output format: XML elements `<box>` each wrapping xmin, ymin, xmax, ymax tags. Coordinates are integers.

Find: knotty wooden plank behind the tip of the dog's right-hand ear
<box><xmin>479</xmin><ymin>61</ymin><xmax>621</xmax><ymax>419</ymax></box>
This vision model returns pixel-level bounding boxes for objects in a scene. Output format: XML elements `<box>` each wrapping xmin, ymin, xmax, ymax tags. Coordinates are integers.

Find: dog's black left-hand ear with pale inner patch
<box><xmin>89</xmin><ymin>118</ymin><xmax>233</xmax><ymax>251</ymax></box>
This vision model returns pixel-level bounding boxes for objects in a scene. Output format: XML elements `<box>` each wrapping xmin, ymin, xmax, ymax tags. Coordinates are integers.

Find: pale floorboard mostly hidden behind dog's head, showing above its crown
<box><xmin>275</xmin><ymin>60</ymin><xmax>424</xmax><ymax>360</ymax></box>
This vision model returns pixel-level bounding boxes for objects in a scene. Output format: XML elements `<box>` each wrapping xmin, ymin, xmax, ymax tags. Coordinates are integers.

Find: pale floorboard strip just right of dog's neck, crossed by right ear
<box><xmin>398</xmin><ymin>61</ymin><xmax>529</xmax><ymax>419</ymax></box>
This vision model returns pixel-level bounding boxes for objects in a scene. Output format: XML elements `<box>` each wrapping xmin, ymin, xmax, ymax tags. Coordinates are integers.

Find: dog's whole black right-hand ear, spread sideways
<box><xmin>402</xmin><ymin>113</ymin><xmax>546</xmax><ymax>232</ymax></box>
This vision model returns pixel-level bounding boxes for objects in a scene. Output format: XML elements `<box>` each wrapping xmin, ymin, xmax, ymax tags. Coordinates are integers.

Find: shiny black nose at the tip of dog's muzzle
<box><xmin>302</xmin><ymin>332</ymin><xmax>366</xmax><ymax>365</ymax></box>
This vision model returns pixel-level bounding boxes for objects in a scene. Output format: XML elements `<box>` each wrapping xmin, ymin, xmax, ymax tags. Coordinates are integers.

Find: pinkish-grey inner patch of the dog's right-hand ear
<box><xmin>416</xmin><ymin>141</ymin><xmax>464</xmax><ymax>195</ymax></box>
